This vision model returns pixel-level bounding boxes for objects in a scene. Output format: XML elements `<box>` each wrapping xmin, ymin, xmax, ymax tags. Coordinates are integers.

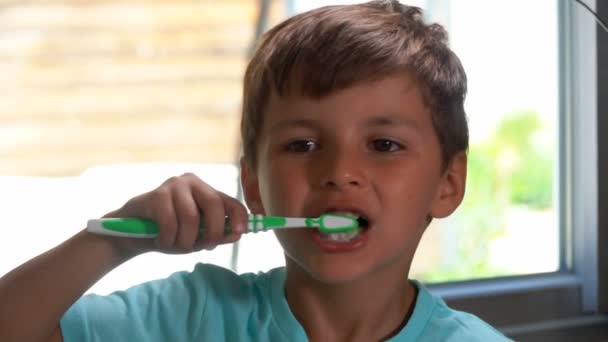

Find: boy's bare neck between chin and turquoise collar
<box><xmin>285</xmin><ymin>258</ymin><xmax>416</xmax><ymax>341</ymax></box>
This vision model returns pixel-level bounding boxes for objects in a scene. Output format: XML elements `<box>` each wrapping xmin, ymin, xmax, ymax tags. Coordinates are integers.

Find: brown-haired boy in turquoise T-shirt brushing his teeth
<box><xmin>0</xmin><ymin>1</ymin><xmax>506</xmax><ymax>341</ymax></box>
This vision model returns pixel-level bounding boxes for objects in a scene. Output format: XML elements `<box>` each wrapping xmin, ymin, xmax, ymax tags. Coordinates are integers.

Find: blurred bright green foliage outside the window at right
<box><xmin>423</xmin><ymin>111</ymin><xmax>554</xmax><ymax>282</ymax></box>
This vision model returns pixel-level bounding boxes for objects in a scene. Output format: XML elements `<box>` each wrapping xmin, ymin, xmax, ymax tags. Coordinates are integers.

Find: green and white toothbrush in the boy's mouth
<box><xmin>87</xmin><ymin>214</ymin><xmax>367</xmax><ymax>238</ymax></box>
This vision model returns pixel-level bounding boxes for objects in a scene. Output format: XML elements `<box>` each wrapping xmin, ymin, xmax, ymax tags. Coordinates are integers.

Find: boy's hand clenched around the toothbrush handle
<box><xmin>104</xmin><ymin>173</ymin><xmax>247</xmax><ymax>253</ymax></box>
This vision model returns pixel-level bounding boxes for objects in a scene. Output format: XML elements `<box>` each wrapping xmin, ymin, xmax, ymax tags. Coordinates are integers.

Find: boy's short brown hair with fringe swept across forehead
<box><xmin>241</xmin><ymin>0</ymin><xmax>469</xmax><ymax>168</ymax></box>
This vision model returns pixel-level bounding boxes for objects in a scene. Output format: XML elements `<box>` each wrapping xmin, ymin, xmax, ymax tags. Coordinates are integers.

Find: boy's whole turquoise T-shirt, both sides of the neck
<box><xmin>61</xmin><ymin>264</ymin><xmax>509</xmax><ymax>342</ymax></box>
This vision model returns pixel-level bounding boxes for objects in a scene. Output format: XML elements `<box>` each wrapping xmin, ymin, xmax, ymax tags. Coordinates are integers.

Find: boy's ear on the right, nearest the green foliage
<box><xmin>430</xmin><ymin>151</ymin><xmax>467</xmax><ymax>218</ymax></box>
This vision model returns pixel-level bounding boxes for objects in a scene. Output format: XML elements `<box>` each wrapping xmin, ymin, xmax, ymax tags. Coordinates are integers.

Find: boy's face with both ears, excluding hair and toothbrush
<box><xmin>242</xmin><ymin>75</ymin><xmax>466</xmax><ymax>283</ymax></box>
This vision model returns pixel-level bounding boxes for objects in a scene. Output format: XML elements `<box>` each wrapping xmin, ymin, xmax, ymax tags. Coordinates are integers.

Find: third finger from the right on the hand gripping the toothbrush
<box><xmin>172</xmin><ymin>180</ymin><xmax>200</xmax><ymax>251</ymax></box>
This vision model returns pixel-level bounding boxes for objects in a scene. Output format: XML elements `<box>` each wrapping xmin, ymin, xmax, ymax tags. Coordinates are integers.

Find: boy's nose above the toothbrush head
<box><xmin>318</xmin><ymin>150</ymin><xmax>366</xmax><ymax>190</ymax></box>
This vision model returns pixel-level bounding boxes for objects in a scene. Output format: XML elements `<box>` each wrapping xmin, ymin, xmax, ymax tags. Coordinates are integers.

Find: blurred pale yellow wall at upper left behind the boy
<box><xmin>0</xmin><ymin>0</ymin><xmax>285</xmax><ymax>176</ymax></box>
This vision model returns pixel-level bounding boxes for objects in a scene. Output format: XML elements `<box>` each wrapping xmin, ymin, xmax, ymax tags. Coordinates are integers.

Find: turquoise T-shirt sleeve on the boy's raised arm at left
<box><xmin>60</xmin><ymin>265</ymin><xmax>207</xmax><ymax>342</ymax></box>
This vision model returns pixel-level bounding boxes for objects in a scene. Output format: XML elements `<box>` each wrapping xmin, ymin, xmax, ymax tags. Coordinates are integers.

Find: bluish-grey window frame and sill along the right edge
<box><xmin>429</xmin><ymin>0</ymin><xmax>608</xmax><ymax>340</ymax></box>
